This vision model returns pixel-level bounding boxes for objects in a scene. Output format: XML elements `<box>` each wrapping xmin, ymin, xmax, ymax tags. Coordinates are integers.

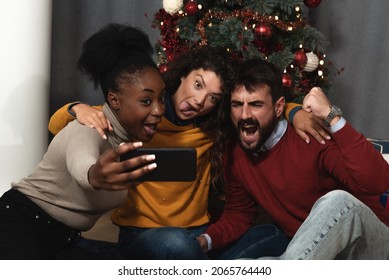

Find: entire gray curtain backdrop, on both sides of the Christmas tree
<box><xmin>50</xmin><ymin>0</ymin><xmax>389</xmax><ymax>139</ymax></box>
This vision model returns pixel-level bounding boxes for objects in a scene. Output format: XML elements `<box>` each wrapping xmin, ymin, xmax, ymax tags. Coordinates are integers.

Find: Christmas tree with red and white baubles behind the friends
<box><xmin>154</xmin><ymin>0</ymin><xmax>330</xmax><ymax>103</ymax></box>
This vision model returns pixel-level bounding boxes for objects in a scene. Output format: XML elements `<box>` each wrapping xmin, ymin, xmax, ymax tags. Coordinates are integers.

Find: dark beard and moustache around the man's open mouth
<box><xmin>237</xmin><ymin>115</ymin><xmax>278</xmax><ymax>153</ymax></box>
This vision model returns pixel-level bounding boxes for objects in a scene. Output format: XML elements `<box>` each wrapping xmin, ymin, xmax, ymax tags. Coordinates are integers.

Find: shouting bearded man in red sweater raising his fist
<box><xmin>198</xmin><ymin>59</ymin><xmax>389</xmax><ymax>259</ymax></box>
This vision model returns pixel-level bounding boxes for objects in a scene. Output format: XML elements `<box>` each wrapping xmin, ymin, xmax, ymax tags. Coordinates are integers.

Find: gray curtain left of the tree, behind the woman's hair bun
<box><xmin>50</xmin><ymin>0</ymin><xmax>162</xmax><ymax>115</ymax></box>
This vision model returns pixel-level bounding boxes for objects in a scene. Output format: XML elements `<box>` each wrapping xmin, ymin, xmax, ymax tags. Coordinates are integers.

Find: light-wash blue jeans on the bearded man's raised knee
<box><xmin>260</xmin><ymin>190</ymin><xmax>389</xmax><ymax>260</ymax></box>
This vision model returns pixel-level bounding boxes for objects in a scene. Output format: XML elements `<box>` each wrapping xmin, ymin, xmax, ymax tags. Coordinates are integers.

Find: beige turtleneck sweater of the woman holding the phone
<box><xmin>12</xmin><ymin>104</ymin><xmax>127</xmax><ymax>231</ymax></box>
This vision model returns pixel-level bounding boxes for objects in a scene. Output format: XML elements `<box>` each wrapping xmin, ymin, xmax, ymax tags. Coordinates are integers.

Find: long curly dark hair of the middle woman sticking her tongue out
<box><xmin>163</xmin><ymin>46</ymin><xmax>237</xmax><ymax>195</ymax></box>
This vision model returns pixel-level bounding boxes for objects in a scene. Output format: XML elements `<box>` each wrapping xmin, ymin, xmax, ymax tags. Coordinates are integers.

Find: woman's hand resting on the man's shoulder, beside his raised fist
<box><xmin>293</xmin><ymin>105</ymin><xmax>331</xmax><ymax>144</ymax></box>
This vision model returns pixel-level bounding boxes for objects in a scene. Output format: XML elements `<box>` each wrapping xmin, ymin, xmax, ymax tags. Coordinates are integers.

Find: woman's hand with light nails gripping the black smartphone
<box><xmin>88</xmin><ymin>142</ymin><xmax>157</xmax><ymax>190</ymax></box>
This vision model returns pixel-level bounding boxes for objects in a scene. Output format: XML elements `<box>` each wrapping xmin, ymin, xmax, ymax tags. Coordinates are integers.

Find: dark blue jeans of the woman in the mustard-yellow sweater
<box><xmin>118</xmin><ymin>225</ymin><xmax>289</xmax><ymax>260</ymax></box>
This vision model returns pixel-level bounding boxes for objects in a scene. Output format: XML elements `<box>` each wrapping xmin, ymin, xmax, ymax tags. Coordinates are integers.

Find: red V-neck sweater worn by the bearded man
<box><xmin>207</xmin><ymin>123</ymin><xmax>389</xmax><ymax>249</ymax></box>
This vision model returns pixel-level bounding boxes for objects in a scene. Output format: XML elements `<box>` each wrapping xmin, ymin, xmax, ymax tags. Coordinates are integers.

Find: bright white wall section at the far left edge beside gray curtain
<box><xmin>0</xmin><ymin>0</ymin><xmax>52</xmax><ymax>194</ymax></box>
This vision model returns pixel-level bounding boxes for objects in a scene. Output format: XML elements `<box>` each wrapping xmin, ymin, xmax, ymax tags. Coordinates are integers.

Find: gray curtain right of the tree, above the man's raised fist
<box><xmin>310</xmin><ymin>0</ymin><xmax>389</xmax><ymax>139</ymax></box>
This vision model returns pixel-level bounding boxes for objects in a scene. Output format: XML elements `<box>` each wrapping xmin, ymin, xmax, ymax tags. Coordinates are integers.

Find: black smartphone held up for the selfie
<box><xmin>120</xmin><ymin>148</ymin><xmax>197</xmax><ymax>182</ymax></box>
